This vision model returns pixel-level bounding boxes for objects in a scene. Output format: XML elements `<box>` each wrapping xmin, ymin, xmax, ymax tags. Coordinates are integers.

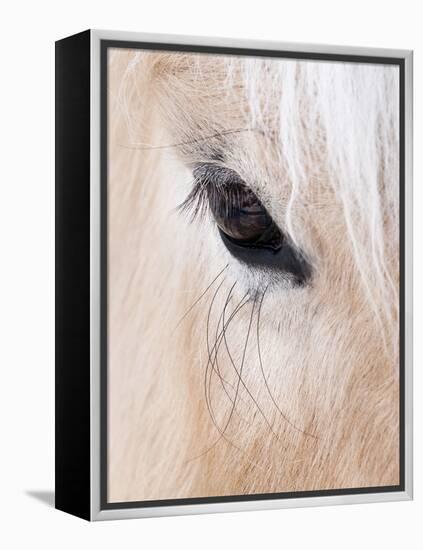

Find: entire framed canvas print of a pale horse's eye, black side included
<box><xmin>56</xmin><ymin>30</ymin><xmax>412</xmax><ymax>520</ymax></box>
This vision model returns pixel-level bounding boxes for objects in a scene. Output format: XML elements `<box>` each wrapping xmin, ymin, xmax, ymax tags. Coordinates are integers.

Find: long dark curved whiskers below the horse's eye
<box><xmin>178</xmin><ymin>265</ymin><xmax>318</xmax><ymax>466</ymax></box>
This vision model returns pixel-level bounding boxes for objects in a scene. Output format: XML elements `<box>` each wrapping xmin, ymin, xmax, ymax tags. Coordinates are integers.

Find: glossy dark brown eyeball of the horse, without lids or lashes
<box><xmin>210</xmin><ymin>181</ymin><xmax>283</xmax><ymax>252</ymax></box>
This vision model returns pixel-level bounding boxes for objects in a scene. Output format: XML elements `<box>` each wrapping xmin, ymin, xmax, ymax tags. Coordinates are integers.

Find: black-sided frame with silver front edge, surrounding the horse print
<box><xmin>55</xmin><ymin>31</ymin><xmax>412</xmax><ymax>520</ymax></box>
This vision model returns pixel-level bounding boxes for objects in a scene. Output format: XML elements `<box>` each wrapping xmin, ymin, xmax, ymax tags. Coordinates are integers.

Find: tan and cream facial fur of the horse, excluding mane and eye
<box><xmin>108</xmin><ymin>50</ymin><xmax>399</xmax><ymax>502</ymax></box>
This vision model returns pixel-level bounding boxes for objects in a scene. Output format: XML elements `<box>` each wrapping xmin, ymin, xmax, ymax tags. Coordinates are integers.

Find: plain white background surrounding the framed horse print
<box><xmin>0</xmin><ymin>0</ymin><xmax>423</xmax><ymax>550</ymax></box>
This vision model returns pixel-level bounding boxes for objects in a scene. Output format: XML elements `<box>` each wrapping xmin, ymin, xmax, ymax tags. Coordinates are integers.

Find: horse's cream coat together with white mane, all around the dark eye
<box><xmin>109</xmin><ymin>50</ymin><xmax>399</xmax><ymax>500</ymax></box>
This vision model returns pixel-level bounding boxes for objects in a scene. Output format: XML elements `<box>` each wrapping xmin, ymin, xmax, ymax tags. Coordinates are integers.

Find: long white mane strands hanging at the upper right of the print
<box><xmin>243</xmin><ymin>59</ymin><xmax>399</xmax><ymax>336</ymax></box>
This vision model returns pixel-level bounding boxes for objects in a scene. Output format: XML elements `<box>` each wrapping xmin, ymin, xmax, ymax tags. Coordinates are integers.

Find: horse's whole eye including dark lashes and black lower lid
<box><xmin>180</xmin><ymin>164</ymin><xmax>311</xmax><ymax>286</ymax></box>
